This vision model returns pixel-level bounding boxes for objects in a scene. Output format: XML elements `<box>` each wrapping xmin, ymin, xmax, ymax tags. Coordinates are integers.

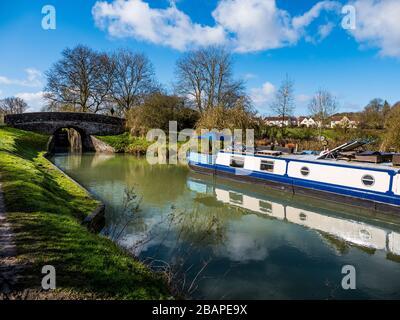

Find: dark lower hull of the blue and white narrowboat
<box><xmin>189</xmin><ymin>163</ymin><xmax>400</xmax><ymax>215</ymax></box>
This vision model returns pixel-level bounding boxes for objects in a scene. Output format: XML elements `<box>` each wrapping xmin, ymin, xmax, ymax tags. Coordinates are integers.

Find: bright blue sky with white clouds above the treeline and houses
<box><xmin>0</xmin><ymin>0</ymin><xmax>400</xmax><ymax>114</ymax></box>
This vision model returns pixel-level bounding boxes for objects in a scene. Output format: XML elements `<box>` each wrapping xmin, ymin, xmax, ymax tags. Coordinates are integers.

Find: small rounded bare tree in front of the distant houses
<box><xmin>308</xmin><ymin>89</ymin><xmax>338</xmax><ymax>135</ymax></box>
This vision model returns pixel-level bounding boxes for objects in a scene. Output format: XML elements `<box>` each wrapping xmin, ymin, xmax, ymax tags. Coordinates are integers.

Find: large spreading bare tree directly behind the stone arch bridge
<box><xmin>45</xmin><ymin>45</ymin><xmax>113</xmax><ymax>113</ymax></box>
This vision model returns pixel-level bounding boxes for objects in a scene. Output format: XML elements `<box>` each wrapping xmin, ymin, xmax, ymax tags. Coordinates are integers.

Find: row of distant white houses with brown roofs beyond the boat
<box><xmin>264</xmin><ymin>115</ymin><xmax>359</xmax><ymax>129</ymax></box>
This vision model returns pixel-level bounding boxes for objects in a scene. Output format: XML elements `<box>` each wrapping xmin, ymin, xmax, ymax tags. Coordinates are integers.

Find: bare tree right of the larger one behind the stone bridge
<box><xmin>111</xmin><ymin>49</ymin><xmax>157</xmax><ymax>114</ymax></box>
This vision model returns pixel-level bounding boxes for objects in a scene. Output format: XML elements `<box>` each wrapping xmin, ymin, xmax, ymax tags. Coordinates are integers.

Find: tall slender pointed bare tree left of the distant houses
<box><xmin>271</xmin><ymin>75</ymin><xmax>295</xmax><ymax>135</ymax></box>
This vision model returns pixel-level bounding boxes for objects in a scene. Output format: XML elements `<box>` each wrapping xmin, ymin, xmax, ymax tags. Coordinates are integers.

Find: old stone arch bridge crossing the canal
<box><xmin>4</xmin><ymin>112</ymin><xmax>125</xmax><ymax>152</ymax></box>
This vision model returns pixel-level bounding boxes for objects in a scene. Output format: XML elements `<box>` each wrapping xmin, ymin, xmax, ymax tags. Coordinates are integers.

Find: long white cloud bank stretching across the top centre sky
<box><xmin>92</xmin><ymin>0</ymin><xmax>338</xmax><ymax>52</ymax></box>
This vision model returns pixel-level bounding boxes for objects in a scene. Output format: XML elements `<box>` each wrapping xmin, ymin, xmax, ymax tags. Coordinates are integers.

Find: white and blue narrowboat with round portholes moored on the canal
<box><xmin>188</xmin><ymin>141</ymin><xmax>400</xmax><ymax>214</ymax></box>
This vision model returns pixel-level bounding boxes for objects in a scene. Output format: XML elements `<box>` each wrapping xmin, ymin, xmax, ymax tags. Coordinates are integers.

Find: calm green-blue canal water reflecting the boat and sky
<box><xmin>53</xmin><ymin>154</ymin><xmax>400</xmax><ymax>299</ymax></box>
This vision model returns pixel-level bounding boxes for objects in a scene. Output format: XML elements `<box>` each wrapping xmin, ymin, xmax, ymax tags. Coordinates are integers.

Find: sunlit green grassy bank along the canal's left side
<box><xmin>0</xmin><ymin>127</ymin><xmax>169</xmax><ymax>299</ymax></box>
